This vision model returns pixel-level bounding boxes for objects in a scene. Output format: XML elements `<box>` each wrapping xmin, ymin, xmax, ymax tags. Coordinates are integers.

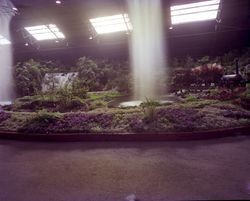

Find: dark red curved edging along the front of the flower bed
<box><xmin>0</xmin><ymin>126</ymin><xmax>250</xmax><ymax>142</ymax></box>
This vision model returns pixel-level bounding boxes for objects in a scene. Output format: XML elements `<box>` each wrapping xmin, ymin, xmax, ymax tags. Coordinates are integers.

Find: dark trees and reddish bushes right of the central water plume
<box><xmin>171</xmin><ymin>48</ymin><xmax>250</xmax><ymax>88</ymax></box>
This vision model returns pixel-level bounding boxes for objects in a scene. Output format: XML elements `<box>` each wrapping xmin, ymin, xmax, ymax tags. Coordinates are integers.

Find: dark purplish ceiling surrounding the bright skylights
<box><xmin>7</xmin><ymin>0</ymin><xmax>250</xmax><ymax>60</ymax></box>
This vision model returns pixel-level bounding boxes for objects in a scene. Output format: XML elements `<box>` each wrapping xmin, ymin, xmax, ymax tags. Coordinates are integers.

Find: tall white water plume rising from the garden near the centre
<box><xmin>127</xmin><ymin>0</ymin><xmax>166</xmax><ymax>101</ymax></box>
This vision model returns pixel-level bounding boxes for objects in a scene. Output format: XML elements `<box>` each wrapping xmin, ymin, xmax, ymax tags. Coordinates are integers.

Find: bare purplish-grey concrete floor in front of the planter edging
<box><xmin>0</xmin><ymin>137</ymin><xmax>250</xmax><ymax>201</ymax></box>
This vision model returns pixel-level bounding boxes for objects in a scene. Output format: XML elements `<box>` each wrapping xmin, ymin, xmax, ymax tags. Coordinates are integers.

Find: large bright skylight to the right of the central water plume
<box><xmin>171</xmin><ymin>0</ymin><xmax>220</xmax><ymax>24</ymax></box>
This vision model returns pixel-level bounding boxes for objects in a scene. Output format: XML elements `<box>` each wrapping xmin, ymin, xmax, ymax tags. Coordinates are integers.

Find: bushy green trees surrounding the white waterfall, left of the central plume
<box><xmin>14</xmin><ymin>57</ymin><xmax>131</xmax><ymax>96</ymax></box>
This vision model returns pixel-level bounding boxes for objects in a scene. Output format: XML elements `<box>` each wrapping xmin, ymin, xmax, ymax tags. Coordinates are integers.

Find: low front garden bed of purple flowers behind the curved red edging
<box><xmin>0</xmin><ymin>94</ymin><xmax>250</xmax><ymax>135</ymax></box>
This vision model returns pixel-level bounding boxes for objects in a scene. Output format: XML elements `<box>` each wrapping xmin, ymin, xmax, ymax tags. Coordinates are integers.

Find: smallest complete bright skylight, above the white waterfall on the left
<box><xmin>25</xmin><ymin>24</ymin><xmax>65</xmax><ymax>41</ymax></box>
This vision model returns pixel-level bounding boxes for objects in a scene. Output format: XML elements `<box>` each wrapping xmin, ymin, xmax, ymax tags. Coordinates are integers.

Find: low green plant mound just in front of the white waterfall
<box><xmin>10</xmin><ymin>88</ymin><xmax>120</xmax><ymax>113</ymax></box>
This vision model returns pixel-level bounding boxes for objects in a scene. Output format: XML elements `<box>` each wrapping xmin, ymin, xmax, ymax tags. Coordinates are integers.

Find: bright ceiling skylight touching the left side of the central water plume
<box><xmin>89</xmin><ymin>14</ymin><xmax>132</xmax><ymax>34</ymax></box>
